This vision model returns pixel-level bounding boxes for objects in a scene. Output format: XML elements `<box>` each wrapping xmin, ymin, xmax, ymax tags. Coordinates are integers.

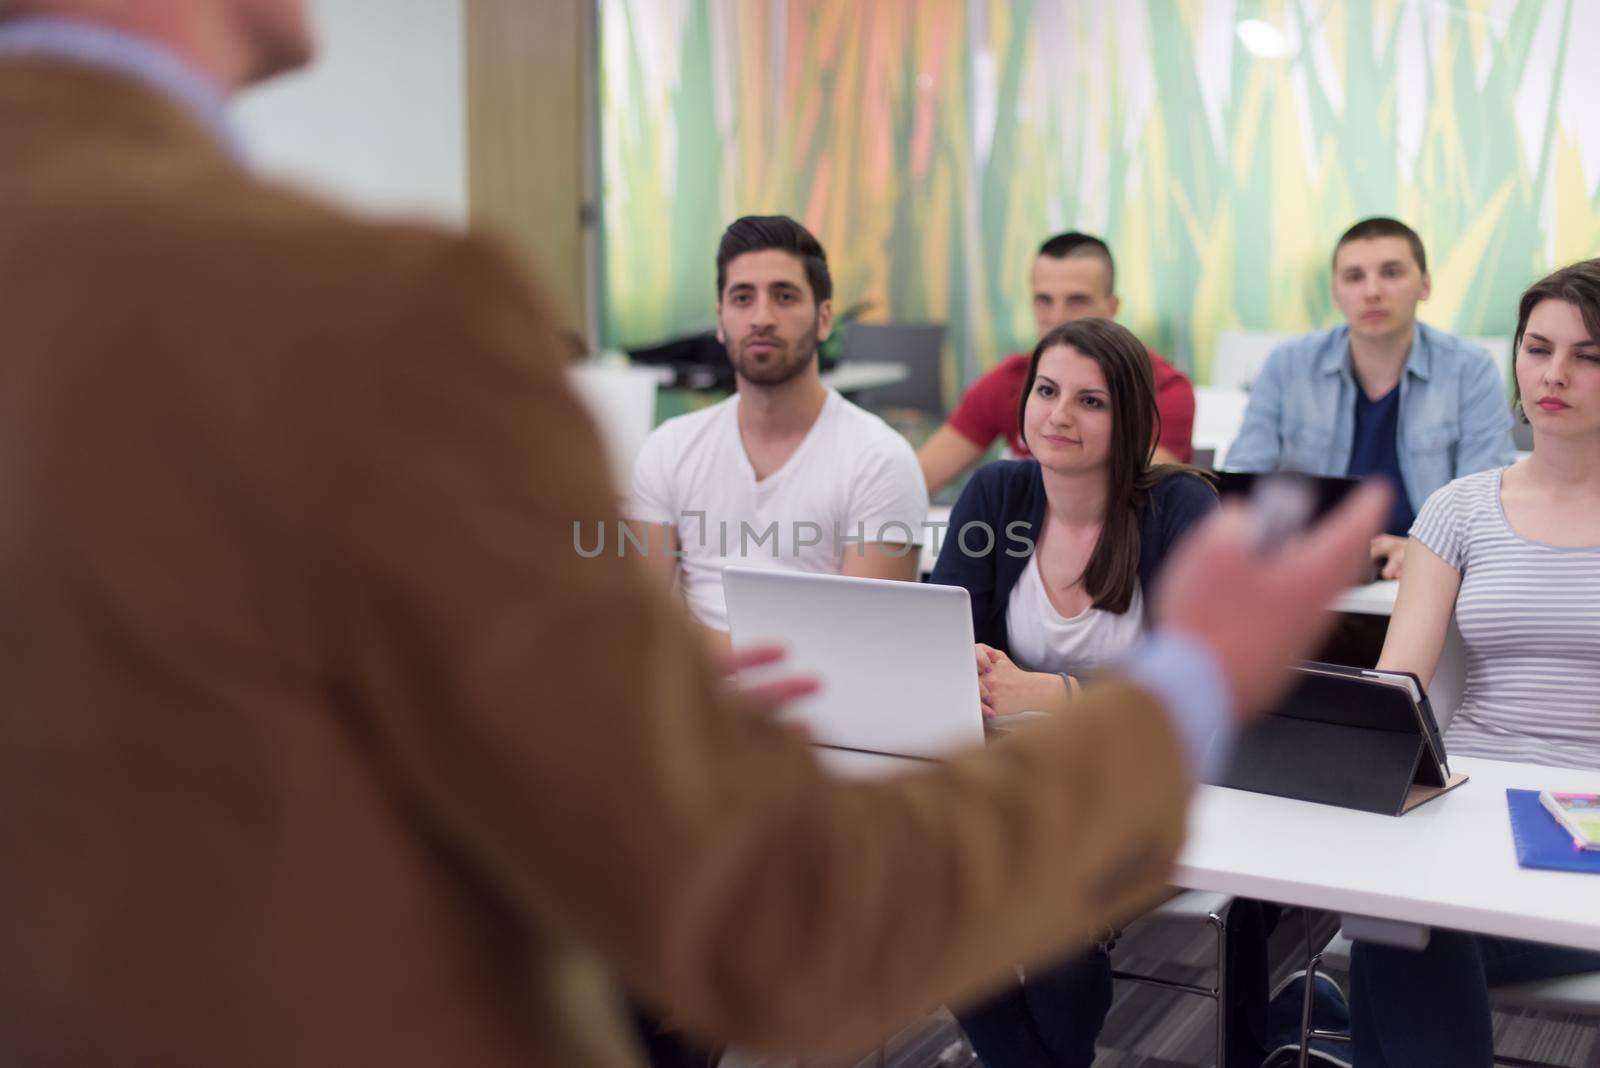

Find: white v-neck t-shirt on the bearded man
<box><xmin>627</xmin><ymin>390</ymin><xmax>928</xmax><ymax>630</ymax></box>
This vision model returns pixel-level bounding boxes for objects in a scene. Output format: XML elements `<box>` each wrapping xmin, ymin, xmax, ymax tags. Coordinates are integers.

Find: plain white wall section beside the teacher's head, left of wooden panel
<box><xmin>235</xmin><ymin>0</ymin><xmax>467</xmax><ymax>225</ymax></box>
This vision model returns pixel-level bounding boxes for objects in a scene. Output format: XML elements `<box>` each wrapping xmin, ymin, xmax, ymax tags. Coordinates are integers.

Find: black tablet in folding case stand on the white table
<box><xmin>1213</xmin><ymin>664</ymin><xmax>1466</xmax><ymax>815</ymax></box>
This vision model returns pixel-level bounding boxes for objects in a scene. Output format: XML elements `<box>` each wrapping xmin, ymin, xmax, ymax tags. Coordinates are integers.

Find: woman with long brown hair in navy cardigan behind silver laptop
<box><xmin>933</xmin><ymin>318</ymin><xmax>1216</xmax><ymax>1068</ymax></box>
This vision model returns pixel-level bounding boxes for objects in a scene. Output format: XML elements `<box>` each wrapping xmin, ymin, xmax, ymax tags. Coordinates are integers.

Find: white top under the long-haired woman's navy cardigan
<box><xmin>1005</xmin><ymin>553</ymin><xmax>1144</xmax><ymax>676</ymax></box>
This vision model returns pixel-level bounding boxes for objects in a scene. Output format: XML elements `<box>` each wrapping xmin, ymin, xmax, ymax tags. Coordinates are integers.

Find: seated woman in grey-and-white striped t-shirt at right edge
<box><xmin>1350</xmin><ymin>259</ymin><xmax>1600</xmax><ymax>1068</ymax></box>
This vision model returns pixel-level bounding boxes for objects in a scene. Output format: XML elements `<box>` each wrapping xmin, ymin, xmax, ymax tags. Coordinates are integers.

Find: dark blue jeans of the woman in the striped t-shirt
<box><xmin>1350</xmin><ymin>929</ymin><xmax>1600</xmax><ymax>1068</ymax></box>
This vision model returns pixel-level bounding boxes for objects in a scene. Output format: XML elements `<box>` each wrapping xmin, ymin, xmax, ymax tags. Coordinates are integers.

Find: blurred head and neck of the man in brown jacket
<box><xmin>0</xmin><ymin>0</ymin><xmax>312</xmax><ymax>91</ymax></box>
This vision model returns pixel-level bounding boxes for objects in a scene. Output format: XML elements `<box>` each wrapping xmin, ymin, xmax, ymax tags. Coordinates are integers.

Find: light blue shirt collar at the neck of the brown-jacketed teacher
<box><xmin>0</xmin><ymin>18</ymin><xmax>243</xmax><ymax>158</ymax></box>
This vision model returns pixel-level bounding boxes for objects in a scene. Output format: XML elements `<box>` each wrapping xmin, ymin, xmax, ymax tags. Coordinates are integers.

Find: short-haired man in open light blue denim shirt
<box><xmin>1227</xmin><ymin>217</ymin><xmax>1517</xmax><ymax>579</ymax></box>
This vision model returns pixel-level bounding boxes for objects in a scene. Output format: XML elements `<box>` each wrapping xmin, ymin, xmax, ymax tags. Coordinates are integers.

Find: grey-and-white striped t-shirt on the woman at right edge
<box><xmin>1411</xmin><ymin>468</ymin><xmax>1600</xmax><ymax>769</ymax></box>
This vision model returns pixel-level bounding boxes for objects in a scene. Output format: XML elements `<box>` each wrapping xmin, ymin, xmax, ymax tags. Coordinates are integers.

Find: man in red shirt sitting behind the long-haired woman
<box><xmin>917</xmin><ymin>232</ymin><xmax>1195</xmax><ymax>496</ymax></box>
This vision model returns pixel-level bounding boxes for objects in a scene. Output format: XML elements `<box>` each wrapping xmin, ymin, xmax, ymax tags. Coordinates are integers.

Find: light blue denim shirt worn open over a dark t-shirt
<box><xmin>1226</xmin><ymin>323</ymin><xmax>1517</xmax><ymax>510</ymax></box>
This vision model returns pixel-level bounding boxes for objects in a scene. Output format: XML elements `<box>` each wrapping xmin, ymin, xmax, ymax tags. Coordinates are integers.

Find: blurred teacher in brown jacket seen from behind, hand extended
<box><xmin>0</xmin><ymin>0</ymin><xmax>1384</xmax><ymax>1068</ymax></box>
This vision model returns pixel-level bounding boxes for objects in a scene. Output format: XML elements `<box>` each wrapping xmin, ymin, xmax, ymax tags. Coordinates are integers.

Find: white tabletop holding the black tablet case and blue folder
<box><xmin>1173</xmin><ymin>756</ymin><xmax>1600</xmax><ymax>950</ymax></box>
